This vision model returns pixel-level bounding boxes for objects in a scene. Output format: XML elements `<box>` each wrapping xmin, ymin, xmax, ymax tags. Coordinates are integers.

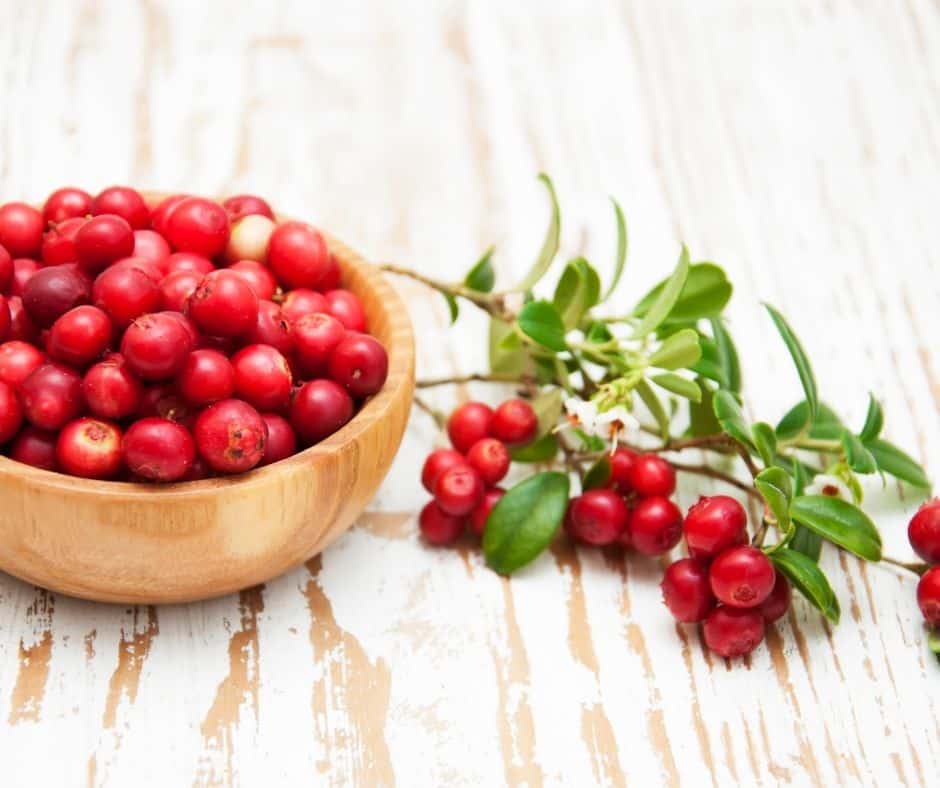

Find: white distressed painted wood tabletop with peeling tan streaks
<box><xmin>0</xmin><ymin>0</ymin><xmax>940</xmax><ymax>788</ymax></box>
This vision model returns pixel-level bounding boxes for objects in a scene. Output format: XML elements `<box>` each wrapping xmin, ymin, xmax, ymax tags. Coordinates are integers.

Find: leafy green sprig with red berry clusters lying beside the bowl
<box><xmin>383</xmin><ymin>175</ymin><xmax>940</xmax><ymax>657</ymax></box>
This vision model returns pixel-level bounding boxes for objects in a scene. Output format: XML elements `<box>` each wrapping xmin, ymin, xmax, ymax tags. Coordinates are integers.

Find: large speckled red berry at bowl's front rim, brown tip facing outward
<box><xmin>193</xmin><ymin>399</ymin><xmax>267</xmax><ymax>473</ymax></box>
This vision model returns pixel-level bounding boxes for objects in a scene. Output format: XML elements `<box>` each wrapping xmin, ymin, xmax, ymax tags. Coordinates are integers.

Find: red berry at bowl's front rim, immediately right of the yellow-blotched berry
<box><xmin>122</xmin><ymin>418</ymin><xmax>196</xmax><ymax>482</ymax></box>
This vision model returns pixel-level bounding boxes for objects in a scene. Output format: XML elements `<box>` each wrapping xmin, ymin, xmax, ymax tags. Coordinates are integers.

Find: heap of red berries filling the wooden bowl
<box><xmin>0</xmin><ymin>186</ymin><xmax>388</xmax><ymax>482</ymax></box>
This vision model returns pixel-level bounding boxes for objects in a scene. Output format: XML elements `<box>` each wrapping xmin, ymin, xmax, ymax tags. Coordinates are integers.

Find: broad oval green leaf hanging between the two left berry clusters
<box><xmin>483</xmin><ymin>471</ymin><xmax>569</xmax><ymax>575</ymax></box>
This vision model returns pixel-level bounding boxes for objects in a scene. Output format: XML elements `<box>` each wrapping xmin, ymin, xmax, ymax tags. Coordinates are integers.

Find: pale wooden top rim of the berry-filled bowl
<box><xmin>0</xmin><ymin>200</ymin><xmax>414</xmax><ymax>502</ymax></box>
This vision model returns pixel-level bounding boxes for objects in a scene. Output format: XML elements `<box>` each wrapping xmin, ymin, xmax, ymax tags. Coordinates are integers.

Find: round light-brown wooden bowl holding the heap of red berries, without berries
<box><xmin>0</xmin><ymin>205</ymin><xmax>414</xmax><ymax>603</ymax></box>
